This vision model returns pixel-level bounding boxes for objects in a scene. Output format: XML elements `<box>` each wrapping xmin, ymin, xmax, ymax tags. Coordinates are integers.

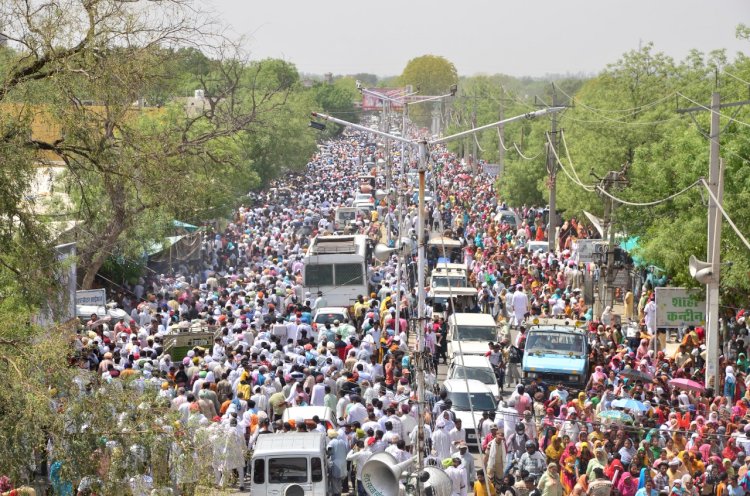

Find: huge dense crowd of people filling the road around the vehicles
<box><xmin>0</xmin><ymin>123</ymin><xmax>750</xmax><ymax>496</ymax></box>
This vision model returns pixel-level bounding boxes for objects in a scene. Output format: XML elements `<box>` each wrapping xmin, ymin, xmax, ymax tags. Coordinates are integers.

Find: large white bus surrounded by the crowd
<box><xmin>302</xmin><ymin>234</ymin><xmax>370</xmax><ymax>307</ymax></box>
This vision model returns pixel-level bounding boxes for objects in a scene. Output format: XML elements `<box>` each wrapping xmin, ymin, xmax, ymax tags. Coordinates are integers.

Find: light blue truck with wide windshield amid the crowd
<box><xmin>521</xmin><ymin>325</ymin><xmax>589</xmax><ymax>389</ymax></box>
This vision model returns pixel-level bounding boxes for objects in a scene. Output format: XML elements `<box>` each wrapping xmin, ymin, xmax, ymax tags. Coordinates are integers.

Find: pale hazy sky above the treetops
<box><xmin>203</xmin><ymin>0</ymin><xmax>750</xmax><ymax>76</ymax></box>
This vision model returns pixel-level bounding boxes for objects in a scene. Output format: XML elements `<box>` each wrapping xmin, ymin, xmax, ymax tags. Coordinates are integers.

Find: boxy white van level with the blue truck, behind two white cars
<box><xmin>447</xmin><ymin>313</ymin><xmax>497</xmax><ymax>360</ymax></box>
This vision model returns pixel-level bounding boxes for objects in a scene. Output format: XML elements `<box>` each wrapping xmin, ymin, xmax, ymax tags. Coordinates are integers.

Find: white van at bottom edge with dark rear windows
<box><xmin>250</xmin><ymin>432</ymin><xmax>328</xmax><ymax>496</ymax></box>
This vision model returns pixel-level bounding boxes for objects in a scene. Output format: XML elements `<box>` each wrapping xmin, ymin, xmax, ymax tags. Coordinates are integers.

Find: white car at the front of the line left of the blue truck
<box><xmin>441</xmin><ymin>379</ymin><xmax>497</xmax><ymax>453</ymax></box>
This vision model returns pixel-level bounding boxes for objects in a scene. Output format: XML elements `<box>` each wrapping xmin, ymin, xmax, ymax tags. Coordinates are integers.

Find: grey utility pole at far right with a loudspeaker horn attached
<box><xmin>677</xmin><ymin>87</ymin><xmax>750</xmax><ymax>392</ymax></box>
